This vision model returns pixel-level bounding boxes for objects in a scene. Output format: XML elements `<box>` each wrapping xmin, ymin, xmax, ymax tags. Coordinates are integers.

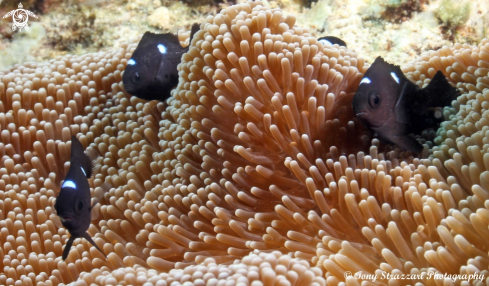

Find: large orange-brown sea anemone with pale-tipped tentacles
<box><xmin>0</xmin><ymin>2</ymin><xmax>489</xmax><ymax>285</ymax></box>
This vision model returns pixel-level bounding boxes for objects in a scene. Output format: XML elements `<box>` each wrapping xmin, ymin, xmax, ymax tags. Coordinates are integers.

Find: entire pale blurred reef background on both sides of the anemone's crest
<box><xmin>0</xmin><ymin>0</ymin><xmax>489</xmax><ymax>70</ymax></box>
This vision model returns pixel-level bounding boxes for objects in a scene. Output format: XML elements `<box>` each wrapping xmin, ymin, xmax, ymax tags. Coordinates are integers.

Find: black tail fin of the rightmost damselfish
<box><xmin>423</xmin><ymin>71</ymin><xmax>460</xmax><ymax>107</ymax></box>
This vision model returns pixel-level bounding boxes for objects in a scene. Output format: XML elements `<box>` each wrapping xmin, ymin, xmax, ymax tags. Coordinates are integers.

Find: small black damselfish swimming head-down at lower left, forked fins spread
<box><xmin>54</xmin><ymin>136</ymin><xmax>105</xmax><ymax>260</ymax></box>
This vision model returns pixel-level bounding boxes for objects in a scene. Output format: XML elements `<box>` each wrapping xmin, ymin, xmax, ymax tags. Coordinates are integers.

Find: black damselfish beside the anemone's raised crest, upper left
<box><xmin>122</xmin><ymin>24</ymin><xmax>200</xmax><ymax>101</ymax></box>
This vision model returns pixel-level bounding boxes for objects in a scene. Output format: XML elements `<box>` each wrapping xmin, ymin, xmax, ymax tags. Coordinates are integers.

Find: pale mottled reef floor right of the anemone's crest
<box><xmin>292</xmin><ymin>0</ymin><xmax>489</xmax><ymax>65</ymax></box>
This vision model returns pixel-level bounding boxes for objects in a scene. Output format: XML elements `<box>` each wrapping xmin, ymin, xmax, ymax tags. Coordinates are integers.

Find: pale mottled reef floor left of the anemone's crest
<box><xmin>0</xmin><ymin>0</ymin><xmax>227</xmax><ymax>70</ymax></box>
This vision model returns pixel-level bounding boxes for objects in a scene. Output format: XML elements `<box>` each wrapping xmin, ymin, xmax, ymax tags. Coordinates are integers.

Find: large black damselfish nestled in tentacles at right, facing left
<box><xmin>353</xmin><ymin>57</ymin><xmax>459</xmax><ymax>153</ymax></box>
